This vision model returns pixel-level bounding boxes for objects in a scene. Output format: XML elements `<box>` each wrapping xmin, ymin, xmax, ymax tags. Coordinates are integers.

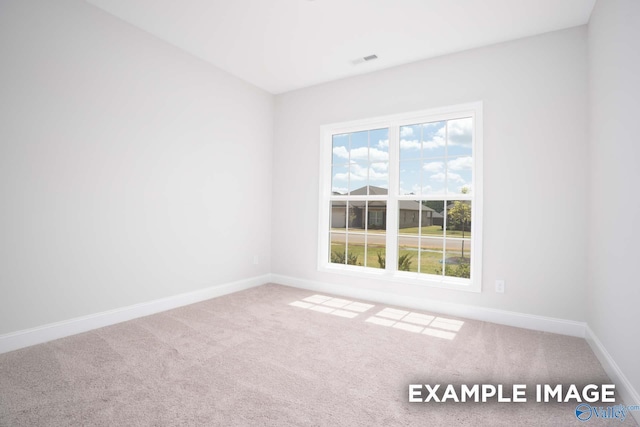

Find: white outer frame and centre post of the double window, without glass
<box><xmin>318</xmin><ymin>102</ymin><xmax>483</xmax><ymax>292</ymax></box>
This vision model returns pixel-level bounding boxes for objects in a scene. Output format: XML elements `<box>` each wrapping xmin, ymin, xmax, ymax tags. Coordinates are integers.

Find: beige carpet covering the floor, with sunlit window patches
<box><xmin>0</xmin><ymin>285</ymin><xmax>636</xmax><ymax>426</ymax></box>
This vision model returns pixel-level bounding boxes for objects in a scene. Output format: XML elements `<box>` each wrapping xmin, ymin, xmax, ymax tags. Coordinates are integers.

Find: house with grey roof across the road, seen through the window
<box><xmin>331</xmin><ymin>185</ymin><xmax>443</xmax><ymax>230</ymax></box>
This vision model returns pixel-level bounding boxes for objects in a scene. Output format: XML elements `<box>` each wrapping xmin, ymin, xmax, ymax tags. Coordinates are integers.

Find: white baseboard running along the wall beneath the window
<box><xmin>271</xmin><ymin>274</ymin><xmax>586</xmax><ymax>338</ymax></box>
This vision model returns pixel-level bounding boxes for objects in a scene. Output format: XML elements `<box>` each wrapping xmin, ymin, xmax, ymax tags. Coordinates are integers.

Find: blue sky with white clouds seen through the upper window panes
<box><xmin>331</xmin><ymin>117</ymin><xmax>473</xmax><ymax>196</ymax></box>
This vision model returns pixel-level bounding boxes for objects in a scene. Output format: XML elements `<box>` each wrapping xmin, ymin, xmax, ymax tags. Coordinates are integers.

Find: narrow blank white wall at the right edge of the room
<box><xmin>588</xmin><ymin>0</ymin><xmax>640</xmax><ymax>404</ymax></box>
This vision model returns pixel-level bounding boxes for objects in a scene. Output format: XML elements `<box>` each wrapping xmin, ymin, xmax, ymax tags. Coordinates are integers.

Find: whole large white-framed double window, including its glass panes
<box><xmin>319</xmin><ymin>103</ymin><xmax>482</xmax><ymax>291</ymax></box>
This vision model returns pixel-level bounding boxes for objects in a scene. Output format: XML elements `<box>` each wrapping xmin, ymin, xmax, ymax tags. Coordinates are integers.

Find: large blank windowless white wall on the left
<box><xmin>0</xmin><ymin>0</ymin><xmax>273</xmax><ymax>334</ymax></box>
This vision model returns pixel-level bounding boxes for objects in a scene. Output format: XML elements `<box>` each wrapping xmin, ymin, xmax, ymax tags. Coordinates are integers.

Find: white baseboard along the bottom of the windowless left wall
<box><xmin>0</xmin><ymin>274</ymin><xmax>271</xmax><ymax>354</ymax></box>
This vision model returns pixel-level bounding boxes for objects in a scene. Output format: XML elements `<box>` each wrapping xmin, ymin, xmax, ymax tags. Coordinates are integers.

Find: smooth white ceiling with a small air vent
<box><xmin>86</xmin><ymin>0</ymin><xmax>596</xmax><ymax>94</ymax></box>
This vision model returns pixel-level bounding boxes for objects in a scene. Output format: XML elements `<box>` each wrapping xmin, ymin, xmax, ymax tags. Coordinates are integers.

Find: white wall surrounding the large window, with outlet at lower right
<box><xmin>272</xmin><ymin>27</ymin><xmax>587</xmax><ymax>321</ymax></box>
